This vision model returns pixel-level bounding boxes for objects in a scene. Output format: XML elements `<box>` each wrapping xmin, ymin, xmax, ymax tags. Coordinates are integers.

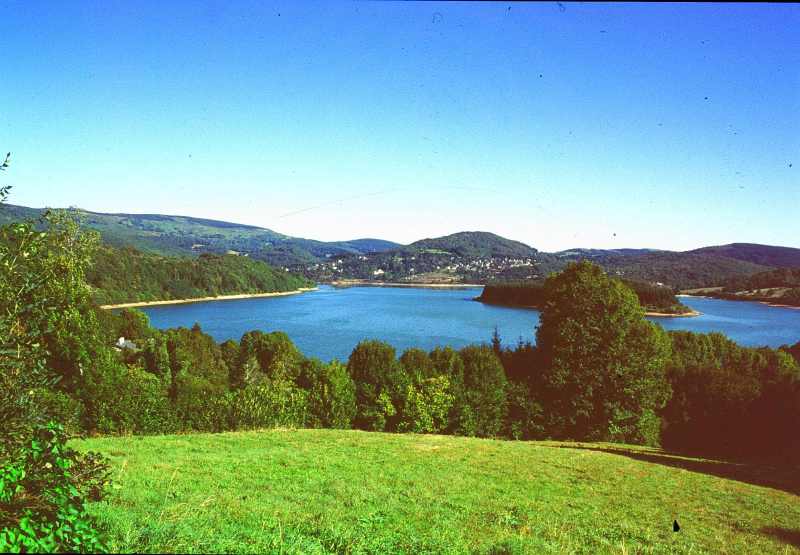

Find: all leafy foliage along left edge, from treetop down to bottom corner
<box><xmin>0</xmin><ymin>165</ymin><xmax>107</xmax><ymax>552</ymax></box>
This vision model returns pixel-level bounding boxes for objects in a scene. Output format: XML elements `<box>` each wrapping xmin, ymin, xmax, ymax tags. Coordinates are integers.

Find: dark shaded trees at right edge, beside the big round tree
<box><xmin>663</xmin><ymin>332</ymin><xmax>800</xmax><ymax>458</ymax></box>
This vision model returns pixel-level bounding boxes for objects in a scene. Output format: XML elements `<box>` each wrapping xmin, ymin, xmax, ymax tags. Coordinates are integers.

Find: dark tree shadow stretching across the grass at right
<box><xmin>557</xmin><ymin>443</ymin><xmax>800</xmax><ymax>498</ymax></box>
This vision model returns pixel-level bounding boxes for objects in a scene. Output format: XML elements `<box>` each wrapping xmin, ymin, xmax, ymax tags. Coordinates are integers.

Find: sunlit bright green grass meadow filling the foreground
<box><xmin>75</xmin><ymin>430</ymin><xmax>800</xmax><ymax>553</ymax></box>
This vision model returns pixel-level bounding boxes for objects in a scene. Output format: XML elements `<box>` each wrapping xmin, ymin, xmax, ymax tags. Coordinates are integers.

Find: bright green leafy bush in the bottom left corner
<box><xmin>0</xmin><ymin>423</ymin><xmax>109</xmax><ymax>553</ymax></box>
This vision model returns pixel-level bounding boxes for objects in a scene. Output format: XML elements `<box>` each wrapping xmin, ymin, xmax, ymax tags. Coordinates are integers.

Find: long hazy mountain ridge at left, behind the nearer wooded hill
<box><xmin>0</xmin><ymin>205</ymin><xmax>400</xmax><ymax>266</ymax></box>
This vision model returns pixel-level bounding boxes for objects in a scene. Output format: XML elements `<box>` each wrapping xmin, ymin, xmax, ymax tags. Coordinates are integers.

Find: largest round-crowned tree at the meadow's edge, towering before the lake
<box><xmin>536</xmin><ymin>261</ymin><xmax>670</xmax><ymax>444</ymax></box>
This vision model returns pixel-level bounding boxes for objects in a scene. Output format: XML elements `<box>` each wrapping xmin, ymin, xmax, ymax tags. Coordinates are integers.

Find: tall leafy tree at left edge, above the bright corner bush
<box><xmin>0</xmin><ymin>214</ymin><xmax>101</xmax><ymax>457</ymax></box>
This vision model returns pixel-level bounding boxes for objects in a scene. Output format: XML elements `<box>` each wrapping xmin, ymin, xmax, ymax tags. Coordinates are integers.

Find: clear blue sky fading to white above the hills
<box><xmin>0</xmin><ymin>0</ymin><xmax>800</xmax><ymax>251</ymax></box>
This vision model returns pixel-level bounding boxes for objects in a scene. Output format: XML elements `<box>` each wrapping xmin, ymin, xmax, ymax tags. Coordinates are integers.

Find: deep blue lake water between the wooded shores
<box><xmin>143</xmin><ymin>285</ymin><xmax>800</xmax><ymax>360</ymax></box>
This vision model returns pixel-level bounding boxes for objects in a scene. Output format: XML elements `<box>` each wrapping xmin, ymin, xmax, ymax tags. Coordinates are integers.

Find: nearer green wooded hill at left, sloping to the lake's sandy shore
<box><xmin>86</xmin><ymin>246</ymin><xmax>313</xmax><ymax>304</ymax></box>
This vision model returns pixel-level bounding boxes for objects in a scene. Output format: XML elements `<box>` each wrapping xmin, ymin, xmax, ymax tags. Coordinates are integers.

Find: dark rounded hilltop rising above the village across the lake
<box><xmin>401</xmin><ymin>231</ymin><xmax>539</xmax><ymax>258</ymax></box>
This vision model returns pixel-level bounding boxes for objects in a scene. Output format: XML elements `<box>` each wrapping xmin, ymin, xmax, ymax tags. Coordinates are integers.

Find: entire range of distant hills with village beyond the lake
<box><xmin>0</xmin><ymin>205</ymin><xmax>800</xmax><ymax>289</ymax></box>
